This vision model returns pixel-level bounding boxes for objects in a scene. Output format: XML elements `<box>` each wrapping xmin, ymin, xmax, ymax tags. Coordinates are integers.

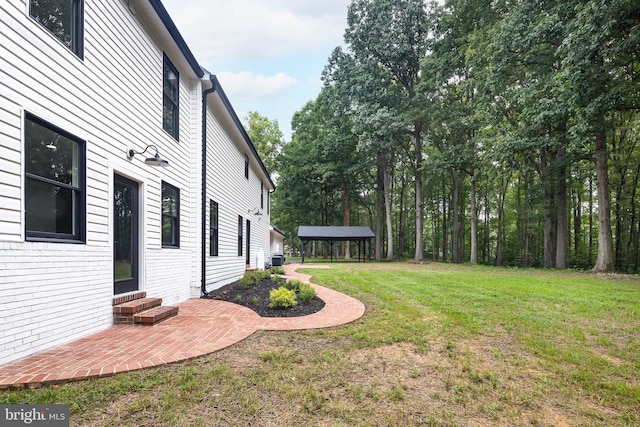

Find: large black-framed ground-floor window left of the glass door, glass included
<box><xmin>24</xmin><ymin>114</ymin><xmax>86</xmax><ymax>242</ymax></box>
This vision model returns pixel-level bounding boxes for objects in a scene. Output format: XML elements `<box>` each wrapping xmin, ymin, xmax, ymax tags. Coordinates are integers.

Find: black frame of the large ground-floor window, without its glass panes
<box><xmin>23</xmin><ymin>113</ymin><xmax>87</xmax><ymax>243</ymax></box>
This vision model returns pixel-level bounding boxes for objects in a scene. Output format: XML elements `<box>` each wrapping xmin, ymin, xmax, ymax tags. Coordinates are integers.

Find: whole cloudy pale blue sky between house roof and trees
<box><xmin>162</xmin><ymin>0</ymin><xmax>350</xmax><ymax>141</ymax></box>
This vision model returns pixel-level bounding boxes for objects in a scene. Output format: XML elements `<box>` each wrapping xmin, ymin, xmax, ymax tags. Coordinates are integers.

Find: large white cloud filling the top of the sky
<box><xmin>164</xmin><ymin>0</ymin><xmax>349</xmax><ymax>66</ymax></box>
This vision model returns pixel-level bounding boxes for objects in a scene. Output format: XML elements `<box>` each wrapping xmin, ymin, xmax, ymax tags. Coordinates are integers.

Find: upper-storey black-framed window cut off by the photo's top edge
<box><xmin>29</xmin><ymin>0</ymin><xmax>84</xmax><ymax>59</ymax></box>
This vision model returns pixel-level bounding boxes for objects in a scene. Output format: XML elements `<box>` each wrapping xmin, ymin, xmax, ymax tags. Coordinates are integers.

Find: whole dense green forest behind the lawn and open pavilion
<box><xmin>247</xmin><ymin>0</ymin><xmax>640</xmax><ymax>273</ymax></box>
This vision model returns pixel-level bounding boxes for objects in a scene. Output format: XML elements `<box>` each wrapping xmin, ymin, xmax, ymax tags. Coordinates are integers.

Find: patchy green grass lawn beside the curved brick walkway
<box><xmin>0</xmin><ymin>262</ymin><xmax>640</xmax><ymax>426</ymax></box>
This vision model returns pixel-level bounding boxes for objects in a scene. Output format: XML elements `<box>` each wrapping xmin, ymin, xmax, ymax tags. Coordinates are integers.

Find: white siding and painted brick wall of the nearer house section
<box><xmin>0</xmin><ymin>0</ymin><xmax>200</xmax><ymax>364</ymax></box>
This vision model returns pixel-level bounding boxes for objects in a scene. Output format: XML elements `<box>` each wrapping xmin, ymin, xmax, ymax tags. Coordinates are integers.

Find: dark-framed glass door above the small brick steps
<box><xmin>113</xmin><ymin>175</ymin><xmax>138</xmax><ymax>295</ymax></box>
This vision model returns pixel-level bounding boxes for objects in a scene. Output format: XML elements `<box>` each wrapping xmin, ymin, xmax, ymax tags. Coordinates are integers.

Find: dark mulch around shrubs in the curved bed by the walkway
<box><xmin>205</xmin><ymin>279</ymin><xmax>324</xmax><ymax>317</ymax></box>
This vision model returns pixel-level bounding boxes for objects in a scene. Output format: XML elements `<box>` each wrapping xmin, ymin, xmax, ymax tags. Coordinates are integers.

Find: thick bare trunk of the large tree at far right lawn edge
<box><xmin>593</xmin><ymin>123</ymin><xmax>614</xmax><ymax>272</ymax></box>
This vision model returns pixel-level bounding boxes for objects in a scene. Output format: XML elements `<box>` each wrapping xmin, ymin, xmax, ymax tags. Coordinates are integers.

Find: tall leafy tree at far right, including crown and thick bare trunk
<box><xmin>562</xmin><ymin>0</ymin><xmax>640</xmax><ymax>272</ymax></box>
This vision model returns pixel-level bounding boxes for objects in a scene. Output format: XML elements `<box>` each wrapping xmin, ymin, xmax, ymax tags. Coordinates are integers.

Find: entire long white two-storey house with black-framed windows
<box><xmin>0</xmin><ymin>0</ymin><xmax>274</xmax><ymax>364</ymax></box>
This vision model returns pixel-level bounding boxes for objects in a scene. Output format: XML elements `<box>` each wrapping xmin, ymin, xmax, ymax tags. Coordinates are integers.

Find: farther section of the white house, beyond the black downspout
<box><xmin>202</xmin><ymin>76</ymin><xmax>275</xmax><ymax>293</ymax></box>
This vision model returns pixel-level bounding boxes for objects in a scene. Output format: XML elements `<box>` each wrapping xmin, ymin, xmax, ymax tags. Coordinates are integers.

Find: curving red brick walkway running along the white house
<box><xmin>0</xmin><ymin>265</ymin><xmax>365</xmax><ymax>389</ymax></box>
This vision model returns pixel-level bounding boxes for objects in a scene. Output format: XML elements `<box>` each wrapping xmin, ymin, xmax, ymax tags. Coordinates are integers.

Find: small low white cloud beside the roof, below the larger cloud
<box><xmin>216</xmin><ymin>71</ymin><xmax>298</xmax><ymax>100</ymax></box>
